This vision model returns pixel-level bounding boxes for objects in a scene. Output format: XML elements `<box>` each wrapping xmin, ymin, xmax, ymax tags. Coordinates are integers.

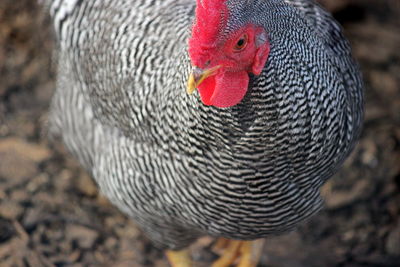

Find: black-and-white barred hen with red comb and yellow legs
<box><xmin>50</xmin><ymin>0</ymin><xmax>363</xmax><ymax>267</ymax></box>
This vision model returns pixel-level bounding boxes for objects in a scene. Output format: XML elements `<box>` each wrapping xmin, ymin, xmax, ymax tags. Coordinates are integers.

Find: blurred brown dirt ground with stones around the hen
<box><xmin>0</xmin><ymin>0</ymin><xmax>400</xmax><ymax>267</ymax></box>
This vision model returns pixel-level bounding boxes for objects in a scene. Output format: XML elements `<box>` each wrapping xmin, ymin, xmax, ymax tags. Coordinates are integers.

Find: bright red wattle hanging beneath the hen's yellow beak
<box><xmin>198</xmin><ymin>71</ymin><xmax>249</xmax><ymax>108</ymax></box>
